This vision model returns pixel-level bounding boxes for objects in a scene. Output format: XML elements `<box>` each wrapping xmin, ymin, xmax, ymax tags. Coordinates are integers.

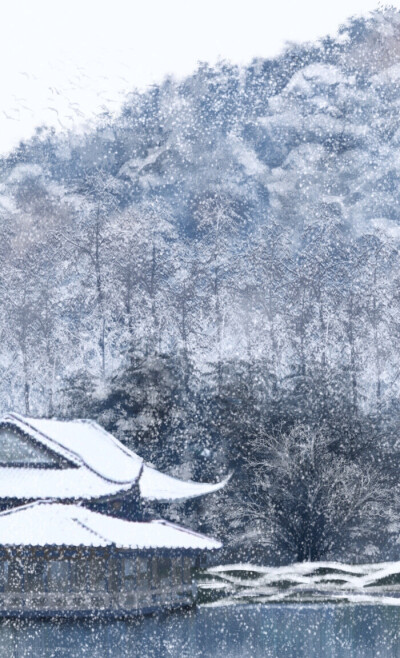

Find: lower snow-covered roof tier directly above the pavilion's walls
<box><xmin>0</xmin><ymin>501</ymin><xmax>222</xmax><ymax>550</ymax></box>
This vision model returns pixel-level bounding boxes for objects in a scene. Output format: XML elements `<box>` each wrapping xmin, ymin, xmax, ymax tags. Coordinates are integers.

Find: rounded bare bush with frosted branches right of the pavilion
<box><xmin>233</xmin><ymin>425</ymin><xmax>390</xmax><ymax>561</ymax></box>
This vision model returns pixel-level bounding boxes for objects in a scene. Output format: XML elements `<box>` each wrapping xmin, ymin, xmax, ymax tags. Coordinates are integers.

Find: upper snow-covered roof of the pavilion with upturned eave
<box><xmin>0</xmin><ymin>413</ymin><xmax>226</xmax><ymax>501</ymax></box>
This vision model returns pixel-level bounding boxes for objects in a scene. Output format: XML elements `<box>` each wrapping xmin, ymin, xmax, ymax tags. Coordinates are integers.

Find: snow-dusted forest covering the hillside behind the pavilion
<box><xmin>0</xmin><ymin>10</ymin><xmax>400</xmax><ymax>559</ymax></box>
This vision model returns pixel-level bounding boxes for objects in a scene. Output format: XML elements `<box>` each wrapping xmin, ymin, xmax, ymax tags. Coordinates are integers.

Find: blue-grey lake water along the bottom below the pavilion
<box><xmin>0</xmin><ymin>604</ymin><xmax>400</xmax><ymax>658</ymax></box>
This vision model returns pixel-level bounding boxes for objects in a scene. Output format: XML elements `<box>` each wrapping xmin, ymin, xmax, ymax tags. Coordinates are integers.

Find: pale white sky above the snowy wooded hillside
<box><xmin>0</xmin><ymin>0</ymin><xmax>400</xmax><ymax>152</ymax></box>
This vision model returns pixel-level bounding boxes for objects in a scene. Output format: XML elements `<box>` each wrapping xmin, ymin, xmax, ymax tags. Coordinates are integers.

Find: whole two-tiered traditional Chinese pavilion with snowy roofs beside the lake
<box><xmin>0</xmin><ymin>414</ymin><xmax>225</xmax><ymax>616</ymax></box>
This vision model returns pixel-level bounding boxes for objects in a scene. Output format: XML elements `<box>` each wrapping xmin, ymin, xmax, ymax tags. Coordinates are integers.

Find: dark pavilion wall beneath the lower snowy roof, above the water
<box><xmin>0</xmin><ymin>549</ymin><xmax>194</xmax><ymax>616</ymax></box>
